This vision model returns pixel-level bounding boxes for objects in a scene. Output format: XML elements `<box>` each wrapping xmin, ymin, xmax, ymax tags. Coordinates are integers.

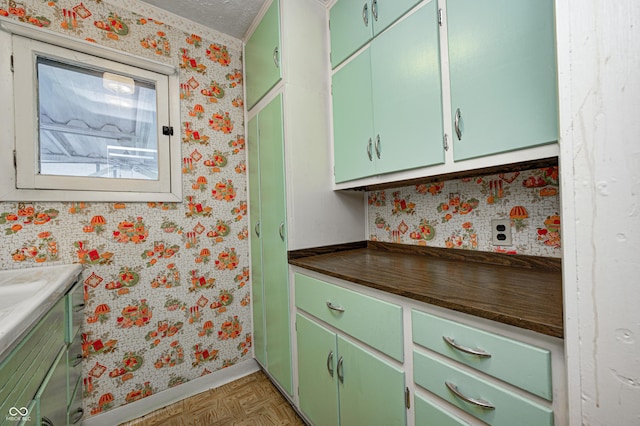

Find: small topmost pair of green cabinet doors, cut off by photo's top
<box><xmin>330</xmin><ymin>0</ymin><xmax>419</xmax><ymax>68</ymax></box>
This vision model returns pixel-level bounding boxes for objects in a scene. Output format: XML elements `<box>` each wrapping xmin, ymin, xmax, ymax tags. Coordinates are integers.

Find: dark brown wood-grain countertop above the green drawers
<box><xmin>289</xmin><ymin>241</ymin><xmax>564</xmax><ymax>338</ymax></box>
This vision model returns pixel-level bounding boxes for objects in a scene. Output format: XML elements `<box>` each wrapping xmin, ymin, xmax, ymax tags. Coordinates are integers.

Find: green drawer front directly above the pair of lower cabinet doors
<box><xmin>295</xmin><ymin>274</ymin><xmax>404</xmax><ymax>362</ymax></box>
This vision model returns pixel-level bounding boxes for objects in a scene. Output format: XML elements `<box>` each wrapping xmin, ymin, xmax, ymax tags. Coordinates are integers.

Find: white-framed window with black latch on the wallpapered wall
<box><xmin>0</xmin><ymin>22</ymin><xmax>181</xmax><ymax>201</ymax></box>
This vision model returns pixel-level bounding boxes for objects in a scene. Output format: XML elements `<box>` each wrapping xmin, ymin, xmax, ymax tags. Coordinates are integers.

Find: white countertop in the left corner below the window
<box><xmin>0</xmin><ymin>265</ymin><xmax>82</xmax><ymax>362</ymax></box>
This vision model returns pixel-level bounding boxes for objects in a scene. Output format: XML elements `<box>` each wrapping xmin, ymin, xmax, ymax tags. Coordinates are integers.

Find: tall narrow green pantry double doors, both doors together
<box><xmin>248</xmin><ymin>94</ymin><xmax>292</xmax><ymax>394</ymax></box>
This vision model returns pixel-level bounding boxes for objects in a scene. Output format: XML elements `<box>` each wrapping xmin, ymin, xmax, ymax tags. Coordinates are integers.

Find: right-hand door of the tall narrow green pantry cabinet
<box><xmin>258</xmin><ymin>94</ymin><xmax>292</xmax><ymax>394</ymax></box>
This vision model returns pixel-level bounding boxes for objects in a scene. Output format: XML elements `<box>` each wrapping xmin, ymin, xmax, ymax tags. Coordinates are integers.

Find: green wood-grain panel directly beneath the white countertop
<box><xmin>0</xmin><ymin>299</ymin><xmax>64</xmax><ymax>413</ymax></box>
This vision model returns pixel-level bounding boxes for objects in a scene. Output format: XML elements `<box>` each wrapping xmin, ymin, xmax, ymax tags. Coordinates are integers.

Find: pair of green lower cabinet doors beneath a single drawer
<box><xmin>296</xmin><ymin>314</ymin><xmax>406</xmax><ymax>426</ymax></box>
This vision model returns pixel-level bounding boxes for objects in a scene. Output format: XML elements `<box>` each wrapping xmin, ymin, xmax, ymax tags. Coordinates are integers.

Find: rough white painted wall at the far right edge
<box><xmin>557</xmin><ymin>0</ymin><xmax>640</xmax><ymax>425</ymax></box>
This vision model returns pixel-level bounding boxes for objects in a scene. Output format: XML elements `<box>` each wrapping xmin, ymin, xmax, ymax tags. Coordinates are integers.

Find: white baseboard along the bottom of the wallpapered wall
<box><xmin>82</xmin><ymin>359</ymin><xmax>260</xmax><ymax>426</ymax></box>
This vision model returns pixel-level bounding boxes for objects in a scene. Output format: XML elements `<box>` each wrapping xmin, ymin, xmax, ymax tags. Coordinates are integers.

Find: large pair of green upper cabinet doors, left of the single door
<box><xmin>332</xmin><ymin>1</ymin><xmax>444</xmax><ymax>182</ymax></box>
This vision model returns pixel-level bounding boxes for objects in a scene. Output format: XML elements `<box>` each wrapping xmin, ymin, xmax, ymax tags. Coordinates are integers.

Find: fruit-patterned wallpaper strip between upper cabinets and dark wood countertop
<box><xmin>368</xmin><ymin>167</ymin><xmax>561</xmax><ymax>257</ymax></box>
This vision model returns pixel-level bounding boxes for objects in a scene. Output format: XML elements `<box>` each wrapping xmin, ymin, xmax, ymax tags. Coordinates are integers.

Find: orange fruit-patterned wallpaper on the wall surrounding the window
<box><xmin>0</xmin><ymin>0</ymin><xmax>251</xmax><ymax>415</ymax></box>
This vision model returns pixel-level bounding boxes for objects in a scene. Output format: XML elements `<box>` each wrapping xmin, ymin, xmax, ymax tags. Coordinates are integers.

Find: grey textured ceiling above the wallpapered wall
<box><xmin>139</xmin><ymin>0</ymin><xmax>266</xmax><ymax>40</ymax></box>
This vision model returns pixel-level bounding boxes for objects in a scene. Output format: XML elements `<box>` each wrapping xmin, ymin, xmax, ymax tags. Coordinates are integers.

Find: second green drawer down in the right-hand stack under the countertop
<box><xmin>413</xmin><ymin>350</ymin><xmax>553</xmax><ymax>426</ymax></box>
